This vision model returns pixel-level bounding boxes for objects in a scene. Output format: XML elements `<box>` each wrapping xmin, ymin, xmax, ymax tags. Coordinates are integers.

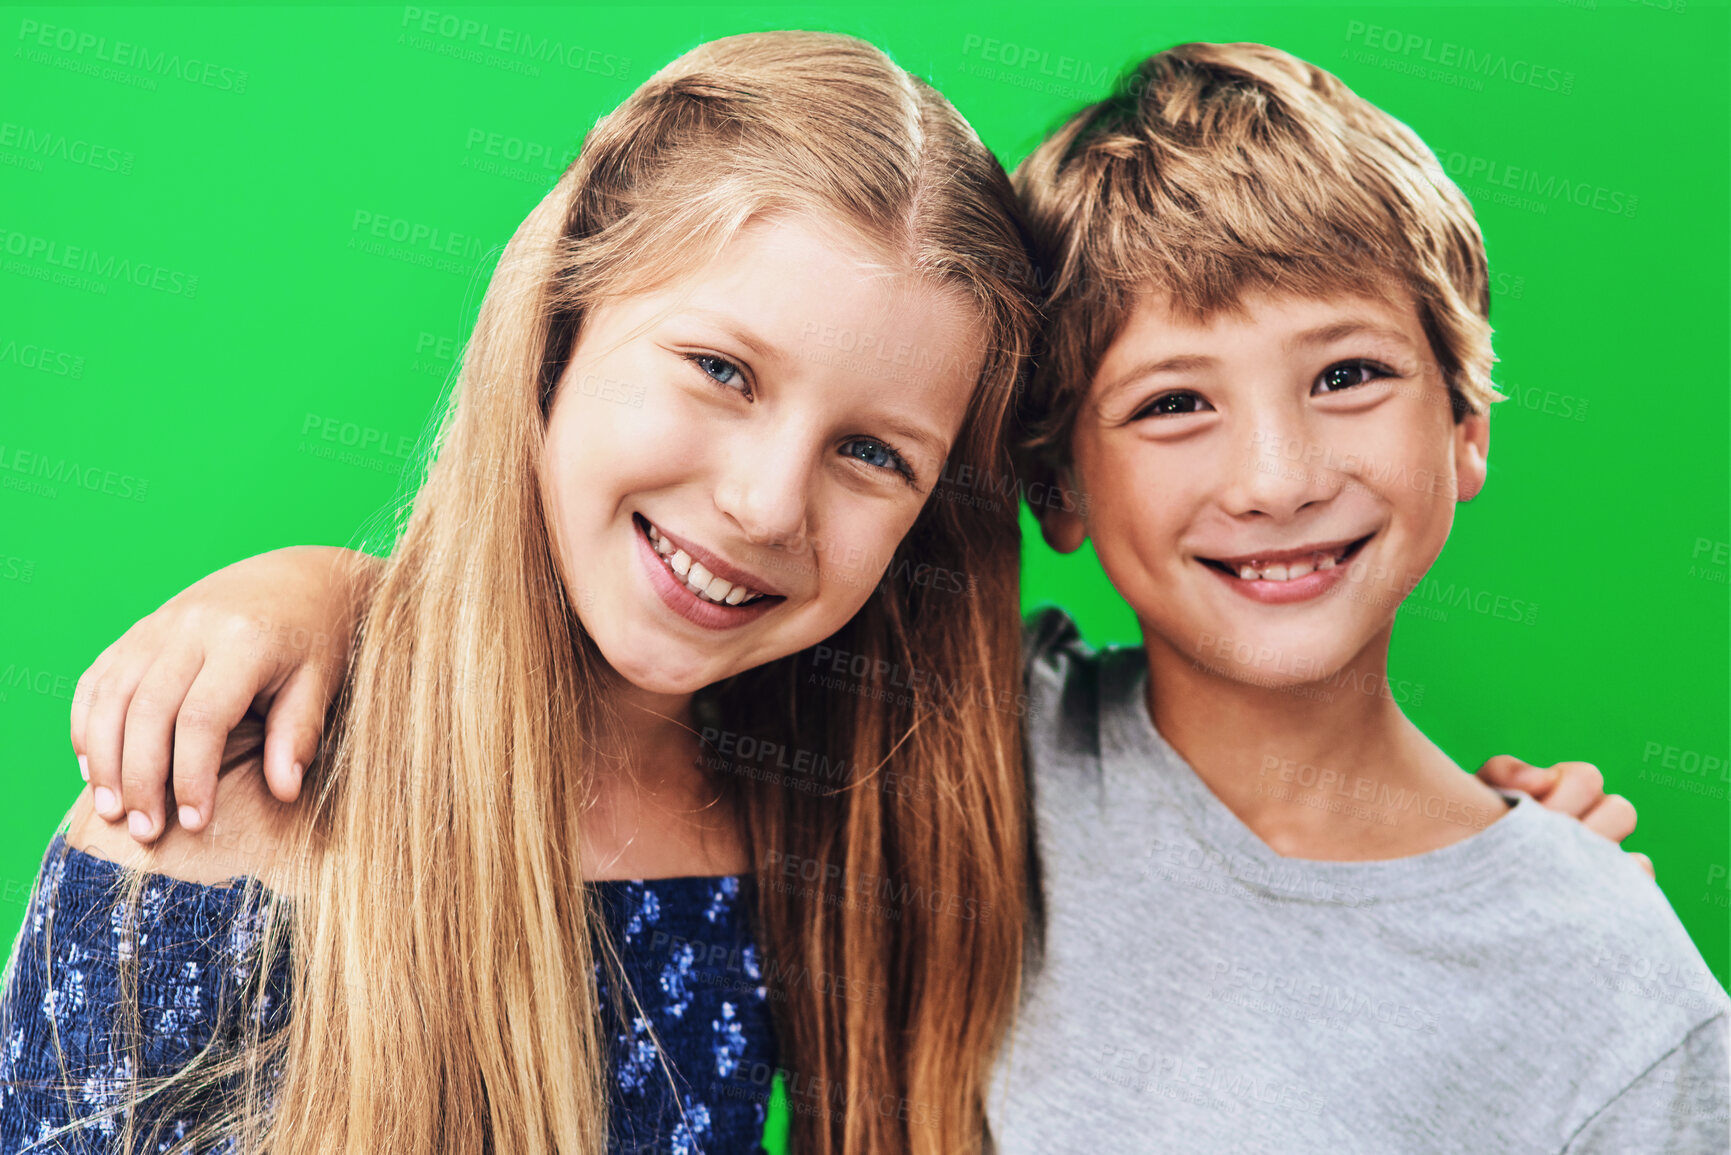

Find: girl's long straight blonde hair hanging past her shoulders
<box><xmin>20</xmin><ymin>33</ymin><xmax>1035</xmax><ymax>1155</ymax></box>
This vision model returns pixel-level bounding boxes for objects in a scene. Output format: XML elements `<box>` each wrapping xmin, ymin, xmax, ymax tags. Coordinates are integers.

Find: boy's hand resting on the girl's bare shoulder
<box><xmin>73</xmin><ymin>545</ymin><xmax>383</xmax><ymax>842</ymax></box>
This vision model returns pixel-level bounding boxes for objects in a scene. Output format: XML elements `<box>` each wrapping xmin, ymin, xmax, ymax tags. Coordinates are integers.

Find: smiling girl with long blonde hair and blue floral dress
<box><xmin>0</xmin><ymin>33</ymin><xmax>1035</xmax><ymax>1155</ymax></box>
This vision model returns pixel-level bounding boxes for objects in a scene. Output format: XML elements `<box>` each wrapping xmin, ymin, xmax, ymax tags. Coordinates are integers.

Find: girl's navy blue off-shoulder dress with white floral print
<box><xmin>0</xmin><ymin>835</ymin><xmax>775</xmax><ymax>1155</ymax></box>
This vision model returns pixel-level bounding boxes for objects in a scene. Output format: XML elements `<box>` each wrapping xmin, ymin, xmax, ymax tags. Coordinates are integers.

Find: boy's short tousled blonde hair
<box><xmin>1014</xmin><ymin>43</ymin><xmax>1501</xmax><ymax>471</ymax></box>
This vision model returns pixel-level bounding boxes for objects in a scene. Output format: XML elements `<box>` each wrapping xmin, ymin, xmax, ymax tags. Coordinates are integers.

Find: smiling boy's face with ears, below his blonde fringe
<box><xmin>1047</xmin><ymin>293</ymin><xmax>1489</xmax><ymax>686</ymax></box>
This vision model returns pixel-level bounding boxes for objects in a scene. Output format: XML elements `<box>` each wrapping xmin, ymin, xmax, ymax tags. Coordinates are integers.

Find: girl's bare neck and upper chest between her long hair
<box><xmin>582</xmin><ymin>684</ymin><xmax>751</xmax><ymax>881</ymax></box>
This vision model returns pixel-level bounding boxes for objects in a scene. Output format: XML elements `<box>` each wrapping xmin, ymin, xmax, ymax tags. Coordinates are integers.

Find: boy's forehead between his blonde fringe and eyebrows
<box><xmin>1092</xmin><ymin>287</ymin><xmax>1432</xmax><ymax>391</ymax></box>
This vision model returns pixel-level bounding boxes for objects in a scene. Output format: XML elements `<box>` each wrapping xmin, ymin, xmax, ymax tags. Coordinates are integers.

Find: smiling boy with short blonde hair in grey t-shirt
<box><xmin>988</xmin><ymin>45</ymin><xmax>1731</xmax><ymax>1155</ymax></box>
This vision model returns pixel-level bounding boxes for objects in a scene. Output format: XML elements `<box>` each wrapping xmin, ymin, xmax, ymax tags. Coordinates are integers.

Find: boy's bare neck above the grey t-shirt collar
<box><xmin>1144</xmin><ymin>632</ymin><xmax>1508</xmax><ymax>861</ymax></box>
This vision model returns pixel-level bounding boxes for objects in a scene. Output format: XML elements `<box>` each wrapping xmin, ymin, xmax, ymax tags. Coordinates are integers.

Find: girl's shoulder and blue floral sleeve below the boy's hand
<box><xmin>0</xmin><ymin>788</ymin><xmax>293</xmax><ymax>1152</ymax></box>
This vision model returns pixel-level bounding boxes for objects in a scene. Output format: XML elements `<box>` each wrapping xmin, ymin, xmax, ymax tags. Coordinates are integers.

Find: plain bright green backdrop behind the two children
<box><xmin>0</xmin><ymin>0</ymin><xmax>1731</xmax><ymax>1135</ymax></box>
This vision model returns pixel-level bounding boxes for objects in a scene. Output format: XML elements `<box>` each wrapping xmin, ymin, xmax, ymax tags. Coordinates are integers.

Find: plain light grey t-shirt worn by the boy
<box><xmin>987</xmin><ymin>611</ymin><xmax>1731</xmax><ymax>1155</ymax></box>
